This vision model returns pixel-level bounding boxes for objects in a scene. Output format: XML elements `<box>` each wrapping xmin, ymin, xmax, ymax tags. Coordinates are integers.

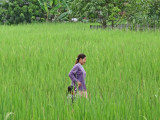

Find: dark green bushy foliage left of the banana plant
<box><xmin>0</xmin><ymin>0</ymin><xmax>45</xmax><ymax>24</ymax></box>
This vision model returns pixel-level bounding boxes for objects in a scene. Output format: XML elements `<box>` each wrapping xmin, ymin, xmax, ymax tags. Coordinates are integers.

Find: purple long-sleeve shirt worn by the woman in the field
<box><xmin>69</xmin><ymin>63</ymin><xmax>86</xmax><ymax>90</ymax></box>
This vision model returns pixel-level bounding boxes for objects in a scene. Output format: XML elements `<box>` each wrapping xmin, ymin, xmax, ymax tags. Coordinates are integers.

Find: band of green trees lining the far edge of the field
<box><xmin>0</xmin><ymin>0</ymin><xmax>160</xmax><ymax>27</ymax></box>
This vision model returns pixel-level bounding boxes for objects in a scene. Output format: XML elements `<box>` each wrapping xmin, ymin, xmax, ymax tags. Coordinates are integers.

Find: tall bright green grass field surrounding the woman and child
<box><xmin>0</xmin><ymin>23</ymin><xmax>160</xmax><ymax>120</ymax></box>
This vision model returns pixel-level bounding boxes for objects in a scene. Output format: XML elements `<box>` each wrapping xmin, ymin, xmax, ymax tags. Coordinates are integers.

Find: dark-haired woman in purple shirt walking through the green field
<box><xmin>69</xmin><ymin>54</ymin><xmax>87</xmax><ymax>98</ymax></box>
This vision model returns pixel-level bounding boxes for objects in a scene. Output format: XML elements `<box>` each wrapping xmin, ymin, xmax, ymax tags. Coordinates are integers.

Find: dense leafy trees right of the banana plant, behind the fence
<box><xmin>72</xmin><ymin>0</ymin><xmax>160</xmax><ymax>26</ymax></box>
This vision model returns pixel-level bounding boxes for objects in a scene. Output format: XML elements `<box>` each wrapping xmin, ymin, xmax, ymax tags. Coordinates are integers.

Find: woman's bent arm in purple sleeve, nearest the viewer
<box><xmin>69</xmin><ymin>64</ymin><xmax>79</xmax><ymax>82</ymax></box>
